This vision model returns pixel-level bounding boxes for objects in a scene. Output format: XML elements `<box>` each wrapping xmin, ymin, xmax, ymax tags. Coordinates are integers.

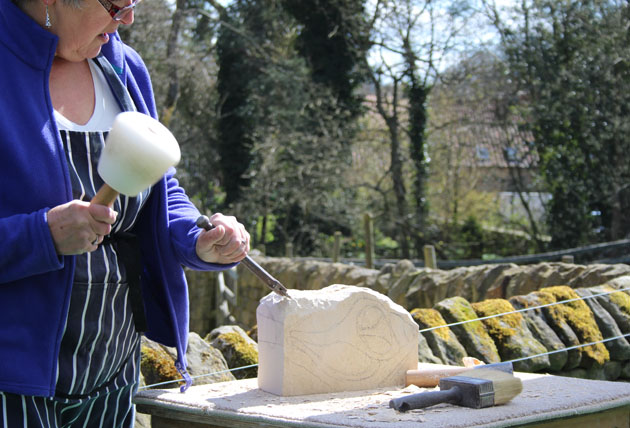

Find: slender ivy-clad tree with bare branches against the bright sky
<box><xmin>370</xmin><ymin>0</ymin><xmax>474</xmax><ymax>258</ymax></box>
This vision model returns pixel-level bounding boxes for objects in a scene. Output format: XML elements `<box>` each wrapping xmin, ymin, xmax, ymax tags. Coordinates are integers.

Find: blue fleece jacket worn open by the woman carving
<box><xmin>0</xmin><ymin>0</ymin><xmax>232</xmax><ymax>396</ymax></box>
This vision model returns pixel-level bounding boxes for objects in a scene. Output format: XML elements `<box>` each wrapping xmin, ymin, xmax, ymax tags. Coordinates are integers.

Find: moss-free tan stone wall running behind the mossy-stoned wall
<box><xmin>187</xmin><ymin>256</ymin><xmax>630</xmax><ymax>335</ymax></box>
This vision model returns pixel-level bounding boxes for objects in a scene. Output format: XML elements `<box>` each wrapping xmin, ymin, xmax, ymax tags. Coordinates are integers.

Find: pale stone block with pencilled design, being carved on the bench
<box><xmin>256</xmin><ymin>284</ymin><xmax>418</xmax><ymax>396</ymax></box>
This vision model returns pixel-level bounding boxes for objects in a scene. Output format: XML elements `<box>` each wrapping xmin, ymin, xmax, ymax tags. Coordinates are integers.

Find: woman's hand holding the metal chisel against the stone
<box><xmin>195</xmin><ymin>213</ymin><xmax>249</xmax><ymax>264</ymax></box>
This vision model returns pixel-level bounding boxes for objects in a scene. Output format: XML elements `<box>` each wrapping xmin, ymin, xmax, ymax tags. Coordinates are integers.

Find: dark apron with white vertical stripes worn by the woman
<box><xmin>0</xmin><ymin>56</ymin><xmax>149</xmax><ymax>428</ymax></box>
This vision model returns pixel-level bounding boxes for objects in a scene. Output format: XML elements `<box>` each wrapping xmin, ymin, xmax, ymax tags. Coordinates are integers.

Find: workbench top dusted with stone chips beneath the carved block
<box><xmin>135</xmin><ymin>364</ymin><xmax>630</xmax><ymax>428</ymax></box>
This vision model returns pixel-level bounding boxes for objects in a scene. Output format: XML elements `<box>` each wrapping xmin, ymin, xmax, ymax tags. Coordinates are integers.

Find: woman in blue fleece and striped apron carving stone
<box><xmin>0</xmin><ymin>0</ymin><xmax>249</xmax><ymax>428</ymax></box>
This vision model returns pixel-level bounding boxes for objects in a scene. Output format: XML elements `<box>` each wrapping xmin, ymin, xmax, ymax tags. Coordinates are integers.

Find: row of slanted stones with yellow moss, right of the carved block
<box><xmin>411</xmin><ymin>276</ymin><xmax>630</xmax><ymax>380</ymax></box>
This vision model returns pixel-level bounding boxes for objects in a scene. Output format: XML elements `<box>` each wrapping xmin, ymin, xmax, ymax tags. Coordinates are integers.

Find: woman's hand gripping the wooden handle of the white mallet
<box><xmin>48</xmin><ymin>200</ymin><xmax>118</xmax><ymax>255</ymax></box>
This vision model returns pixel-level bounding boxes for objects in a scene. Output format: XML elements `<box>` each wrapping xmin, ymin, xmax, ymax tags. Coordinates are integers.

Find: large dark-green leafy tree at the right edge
<box><xmin>486</xmin><ymin>0</ymin><xmax>630</xmax><ymax>248</ymax></box>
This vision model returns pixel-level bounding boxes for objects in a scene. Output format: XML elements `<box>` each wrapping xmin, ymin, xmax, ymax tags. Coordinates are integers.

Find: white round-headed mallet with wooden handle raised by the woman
<box><xmin>91</xmin><ymin>112</ymin><xmax>181</xmax><ymax>207</ymax></box>
